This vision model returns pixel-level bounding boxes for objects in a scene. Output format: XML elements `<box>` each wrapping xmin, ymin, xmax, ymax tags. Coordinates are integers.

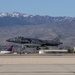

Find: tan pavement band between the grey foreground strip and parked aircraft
<box><xmin>0</xmin><ymin>55</ymin><xmax>75</xmax><ymax>64</ymax></box>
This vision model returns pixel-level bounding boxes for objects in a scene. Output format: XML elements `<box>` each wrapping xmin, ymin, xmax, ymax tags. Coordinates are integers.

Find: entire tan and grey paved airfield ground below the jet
<box><xmin>0</xmin><ymin>55</ymin><xmax>75</xmax><ymax>75</ymax></box>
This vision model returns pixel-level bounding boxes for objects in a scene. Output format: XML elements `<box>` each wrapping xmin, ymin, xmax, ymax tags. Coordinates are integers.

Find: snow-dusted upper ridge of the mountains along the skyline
<box><xmin>0</xmin><ymin>12</ymin><xmax>75</xmax><ymax>22</ymax></box>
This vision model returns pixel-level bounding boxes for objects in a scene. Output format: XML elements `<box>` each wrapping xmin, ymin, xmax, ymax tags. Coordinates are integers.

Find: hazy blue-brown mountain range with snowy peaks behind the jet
<box><xmin>0</xmin><ymin>12</ymin><xmax>75</xmax><ymax>46</ymax></box>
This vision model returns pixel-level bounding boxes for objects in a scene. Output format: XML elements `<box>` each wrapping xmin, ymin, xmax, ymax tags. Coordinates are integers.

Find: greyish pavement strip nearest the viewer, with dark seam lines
<box><xmin>0</xmin><ymin>64</ymin><xmax>75</xmax><ymax>75</ymax></box>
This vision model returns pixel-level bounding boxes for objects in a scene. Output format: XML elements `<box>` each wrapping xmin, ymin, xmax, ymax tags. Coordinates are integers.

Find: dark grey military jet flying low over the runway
<box><xmin>6</xmin><ymin>36</ymin><xmax>63</xmax><ymax>48</ymax></box>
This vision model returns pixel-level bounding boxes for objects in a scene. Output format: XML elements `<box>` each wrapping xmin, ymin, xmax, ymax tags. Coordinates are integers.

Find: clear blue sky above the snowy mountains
<box><xmin>0</xmin><ymin>0</ymin><xmax>75</xmax><ymax>17</ymax></box>
